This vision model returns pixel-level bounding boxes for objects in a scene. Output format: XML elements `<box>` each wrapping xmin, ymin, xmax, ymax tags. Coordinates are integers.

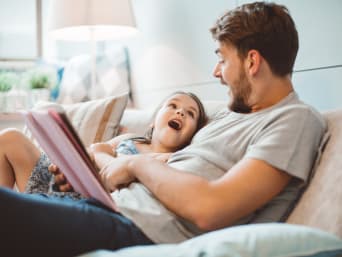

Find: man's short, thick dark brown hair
<box><xmin>210</xmin><ymin>2</ymin><xmax>298</xmax><ymax>76</ymax></box>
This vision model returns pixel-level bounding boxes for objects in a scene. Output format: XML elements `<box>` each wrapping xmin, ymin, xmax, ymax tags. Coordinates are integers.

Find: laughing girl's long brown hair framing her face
<box><xmin>132</xmin><ymin>91</ymin><xmax>208</xmax><ymax>144</ymax></box>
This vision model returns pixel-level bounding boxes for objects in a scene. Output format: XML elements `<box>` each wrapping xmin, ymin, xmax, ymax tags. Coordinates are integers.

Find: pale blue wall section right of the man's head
<box><xmin>278</xmin><ymin>0</ymin><xmax>342</xmax><ymax>111</ymax></box>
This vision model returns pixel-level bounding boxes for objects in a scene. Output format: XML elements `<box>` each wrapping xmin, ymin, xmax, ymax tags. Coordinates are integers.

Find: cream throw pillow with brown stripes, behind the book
<box><xmin>24</xmin><ymin>95</ymin><xmax>128</xmax><ymax>146</ymax></box>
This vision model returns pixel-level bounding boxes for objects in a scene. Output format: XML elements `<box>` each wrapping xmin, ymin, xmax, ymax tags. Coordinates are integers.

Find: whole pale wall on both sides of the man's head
<box><xmin>127</xmin><ymin>0</ymin><xmax>342</xmax><ymax>110</ymax></box>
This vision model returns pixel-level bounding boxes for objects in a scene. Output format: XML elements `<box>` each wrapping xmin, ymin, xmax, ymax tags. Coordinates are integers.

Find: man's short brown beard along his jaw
<box><xmin>228</xmin><ymin>69</ymin><xmax>252</xmax><ymax>113</ymax></box>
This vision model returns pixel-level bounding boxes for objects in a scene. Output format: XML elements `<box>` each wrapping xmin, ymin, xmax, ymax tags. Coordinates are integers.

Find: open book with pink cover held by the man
<box><xmin>23</xmin><ymin>109</ymin><xmax>117</xmax><ymax>211</ymax></box>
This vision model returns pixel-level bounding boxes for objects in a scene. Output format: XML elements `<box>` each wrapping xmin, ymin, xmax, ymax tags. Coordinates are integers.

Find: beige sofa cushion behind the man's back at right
<box><xmin>287</xmin><ymin>110</ymin><xmax>342</xmax><ymax>237</ymax></box>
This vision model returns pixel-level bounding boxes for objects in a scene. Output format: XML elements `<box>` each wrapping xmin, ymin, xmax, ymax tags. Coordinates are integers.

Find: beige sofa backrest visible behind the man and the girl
<box><xmin>121</xmin><ymin>102</ymin><xmax>342</xmax><ymax>237</ymax></box>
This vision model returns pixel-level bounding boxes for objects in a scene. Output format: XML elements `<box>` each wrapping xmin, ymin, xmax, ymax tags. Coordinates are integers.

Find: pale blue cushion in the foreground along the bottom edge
<box><xmin>82</xmin><ymin>223</ymin><xmax>342</xmax><ymax>257</ymax></box>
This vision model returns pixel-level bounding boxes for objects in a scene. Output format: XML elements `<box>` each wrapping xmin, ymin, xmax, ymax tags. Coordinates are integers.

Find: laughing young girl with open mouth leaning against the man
<box><xmin>0</xmin><ymin>92</ymin><xmax>207</xmax><ymax>199</ymax></box>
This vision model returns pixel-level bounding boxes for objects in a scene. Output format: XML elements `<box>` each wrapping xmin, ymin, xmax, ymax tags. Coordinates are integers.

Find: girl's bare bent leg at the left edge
<box><xmin>0</xmin><ymin>129</ymin><xmax>40</xmax><ymax>192</ymax></box>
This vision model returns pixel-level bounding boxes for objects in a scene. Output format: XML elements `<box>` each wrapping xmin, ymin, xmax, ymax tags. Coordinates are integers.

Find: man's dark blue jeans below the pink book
<box><xmin>0</xmin><ymin>188</ymin><xmax>153</xmax><ymax>257</ymax></box>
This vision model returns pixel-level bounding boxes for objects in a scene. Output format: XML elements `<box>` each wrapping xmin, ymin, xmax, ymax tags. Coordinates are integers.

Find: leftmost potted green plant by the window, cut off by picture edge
<box><xmin>0</xmin><ymin>71</ymin><xmax>19</xmax><ymax>112</ymax></box>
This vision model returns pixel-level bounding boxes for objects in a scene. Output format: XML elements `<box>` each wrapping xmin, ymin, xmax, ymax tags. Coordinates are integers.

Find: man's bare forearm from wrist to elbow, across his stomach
<box><xmin>129</xmin><ymin>156</ymin><xmax>218</xmax><ymax>229</ymax></box>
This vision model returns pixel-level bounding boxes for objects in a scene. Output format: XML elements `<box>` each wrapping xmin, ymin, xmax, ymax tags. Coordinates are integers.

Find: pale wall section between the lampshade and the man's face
<box><xmin>129</xmin><ymin>0</ymin><xmax>236</xmax><ymax>107</ymax></box>
